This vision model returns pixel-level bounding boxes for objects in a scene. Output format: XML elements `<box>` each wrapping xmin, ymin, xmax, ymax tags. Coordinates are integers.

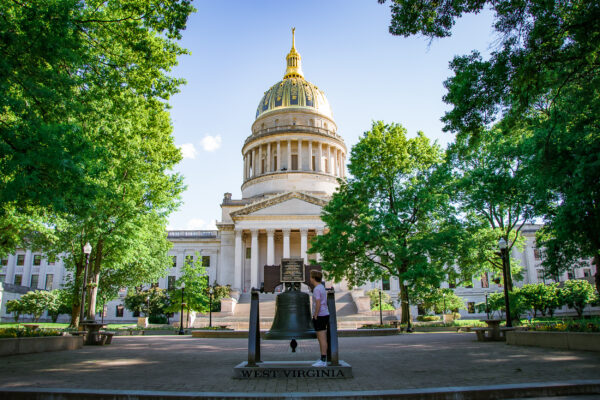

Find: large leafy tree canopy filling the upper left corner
<box><xmin>0</xmin><ymin>0</ymin><xmax>193</xmax><ymax>256</ymax></box>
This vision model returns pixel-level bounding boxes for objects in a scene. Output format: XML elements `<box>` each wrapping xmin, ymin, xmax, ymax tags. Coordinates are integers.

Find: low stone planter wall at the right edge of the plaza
<box><xmin>506</xmin><ymin>331</ymin><xmax>600</xmax><ymax>351</ymax></box>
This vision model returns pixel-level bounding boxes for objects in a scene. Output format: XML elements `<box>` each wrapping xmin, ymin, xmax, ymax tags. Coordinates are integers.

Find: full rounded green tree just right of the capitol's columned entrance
<box><xmin>310</xmin><ymin>122</ymin><xmax>456</xmax><ymax>322</ymax></box>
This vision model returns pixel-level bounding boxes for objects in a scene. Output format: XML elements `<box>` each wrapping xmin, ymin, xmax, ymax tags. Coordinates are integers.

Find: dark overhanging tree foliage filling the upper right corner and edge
<box><xmin>380</xmin><ymin>0</ymin><xmax>600</xmax><ymax>290</ymax></box>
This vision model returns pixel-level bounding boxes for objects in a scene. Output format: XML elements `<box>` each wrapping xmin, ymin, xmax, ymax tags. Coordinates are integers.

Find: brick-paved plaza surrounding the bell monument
<box><xmin>0</xmin><ymin>333</ymin><xmax>600</xmax><ymax>392</ymax></box>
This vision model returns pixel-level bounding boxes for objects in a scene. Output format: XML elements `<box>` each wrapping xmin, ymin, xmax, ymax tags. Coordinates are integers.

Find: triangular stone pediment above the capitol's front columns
<box><xmin>231</xmin><ymin>192</ymin><xmax>327</xmax><ymax>218</ymax></box>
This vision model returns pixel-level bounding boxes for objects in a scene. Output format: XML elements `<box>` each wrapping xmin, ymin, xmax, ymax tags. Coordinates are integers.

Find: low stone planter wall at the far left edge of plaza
<box><xmin>0</xmin><ymin>336</ymin><xmax>83</xmax><ymax>356</ymax></box>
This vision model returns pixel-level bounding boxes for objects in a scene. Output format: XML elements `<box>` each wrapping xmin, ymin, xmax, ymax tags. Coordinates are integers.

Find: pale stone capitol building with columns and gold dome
<box><xmin>0</xmin><ymin>32</ymin><xmax>595</xmax><ymax>322</ymax></box>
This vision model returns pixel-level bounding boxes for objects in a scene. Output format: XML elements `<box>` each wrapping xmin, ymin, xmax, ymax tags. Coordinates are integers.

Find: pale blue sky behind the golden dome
<box><xmin>168</xmin><ymin>0</ymin><xmax>495</xmax><ymax>230</ymax></box>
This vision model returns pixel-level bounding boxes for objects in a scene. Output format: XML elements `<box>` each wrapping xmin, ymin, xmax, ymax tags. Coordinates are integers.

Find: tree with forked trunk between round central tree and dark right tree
<box><xmin>448</xmin><ymin>128</ymin><xmax>535</xmax><ymax>290</ymax></box>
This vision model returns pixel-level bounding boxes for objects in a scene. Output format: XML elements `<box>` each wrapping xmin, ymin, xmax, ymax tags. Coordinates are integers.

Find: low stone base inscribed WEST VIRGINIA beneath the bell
<box><xmin>233</xmin><ymin>360</ymin><xmax>352</xmax><ymax>379</ymax></box>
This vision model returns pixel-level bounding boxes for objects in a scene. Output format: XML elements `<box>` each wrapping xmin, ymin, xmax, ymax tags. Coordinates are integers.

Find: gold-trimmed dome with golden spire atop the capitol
<box><xmin>256</xmin><ymin>28</ymin><xmax>333</xmax><ymax>119</ymax></box>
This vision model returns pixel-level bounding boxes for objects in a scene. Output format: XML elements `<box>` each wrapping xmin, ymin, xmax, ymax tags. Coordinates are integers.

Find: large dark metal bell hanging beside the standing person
<box><xmin>265</xmin><ymin>290</ymin><xmax>317</xmax><ymax>340</ymax></box>
